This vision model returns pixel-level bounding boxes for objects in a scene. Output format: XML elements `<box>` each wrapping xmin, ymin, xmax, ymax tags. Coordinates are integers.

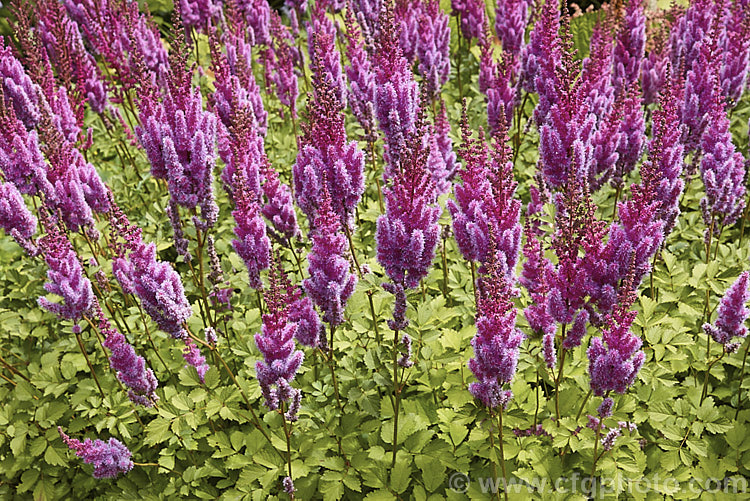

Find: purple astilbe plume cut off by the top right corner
<box><xmin>719</xmin><ymin>2</ymin><xmax>750</xmax><ymax>103</ymax></box>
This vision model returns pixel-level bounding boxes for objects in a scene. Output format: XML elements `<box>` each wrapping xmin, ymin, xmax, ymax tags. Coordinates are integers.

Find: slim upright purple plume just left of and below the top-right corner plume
<box><xmin>680</xmin><ymin>25</ymin><xmax>720</xmax><ymax>152</ymax></box>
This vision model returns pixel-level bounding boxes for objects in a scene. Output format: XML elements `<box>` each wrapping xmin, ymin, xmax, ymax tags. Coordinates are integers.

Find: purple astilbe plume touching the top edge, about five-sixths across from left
<box><xmin>612</xmin><ymin>0</ymin><xmax>646</xmax><ymax>92</ymax></box>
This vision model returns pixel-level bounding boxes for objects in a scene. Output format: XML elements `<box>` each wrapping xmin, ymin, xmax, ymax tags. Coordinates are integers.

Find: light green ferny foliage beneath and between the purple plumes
<box><xmin>0</xmin><ymin>0</ymin><xmax>750</xmax><ymax>500</ymax></box>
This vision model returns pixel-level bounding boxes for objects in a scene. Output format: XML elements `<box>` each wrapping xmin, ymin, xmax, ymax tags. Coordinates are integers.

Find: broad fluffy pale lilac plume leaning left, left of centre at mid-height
<box><xmin>112</xmin><ymin>240</ymin><xmax>193</xmax><ymax>339</ymax></box>
